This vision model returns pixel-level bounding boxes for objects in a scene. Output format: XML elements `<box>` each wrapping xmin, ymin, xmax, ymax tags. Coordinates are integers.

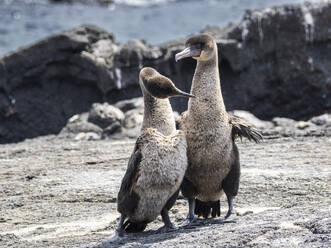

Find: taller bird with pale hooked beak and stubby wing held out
<box><xmin>176</xmin><ymin>34</ymin><xmax>260</xmax><ymax>217</ymax></box>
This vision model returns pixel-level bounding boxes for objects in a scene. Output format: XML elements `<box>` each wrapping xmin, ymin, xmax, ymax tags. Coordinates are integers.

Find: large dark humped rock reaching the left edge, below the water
<box><xmin>0</xmin><ymin>26</ymin><xmax>117</xmax><ymax>143</ymax></box>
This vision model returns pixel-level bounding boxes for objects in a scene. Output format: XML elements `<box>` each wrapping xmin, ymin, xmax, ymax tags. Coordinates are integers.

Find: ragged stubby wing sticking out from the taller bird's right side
<box><xmin>229</xmin><ymin>115</ymin><xmax>263</xmax><ymax>143</ymax></box>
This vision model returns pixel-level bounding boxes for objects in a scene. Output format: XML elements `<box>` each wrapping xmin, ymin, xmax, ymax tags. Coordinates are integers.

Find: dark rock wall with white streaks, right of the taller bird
<box><xmin>213</xmin><ymin>3</ymin><xmax>331</xmax><ymax>119</ymax></box>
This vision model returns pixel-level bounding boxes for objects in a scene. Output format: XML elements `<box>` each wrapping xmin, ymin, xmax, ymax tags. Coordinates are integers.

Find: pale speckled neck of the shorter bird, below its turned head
<box><xmin>141</xmin><ymin>82</ymin><xmax>176</xmax><ymax>135</ymax></box>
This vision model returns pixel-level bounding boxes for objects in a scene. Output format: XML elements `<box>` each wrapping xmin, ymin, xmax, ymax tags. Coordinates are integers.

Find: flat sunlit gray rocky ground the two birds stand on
<box><xmin>0</xmin><ymin>120</ymin><xmax>331</xmax><ymax>248</ymax></box>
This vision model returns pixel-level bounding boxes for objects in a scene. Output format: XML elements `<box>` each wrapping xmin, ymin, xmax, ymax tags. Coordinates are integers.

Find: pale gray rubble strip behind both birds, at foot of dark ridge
<box><xmin>60</xmin><ymin>97</ymin><xmax>331</xmax><ymax>140</ymax></box>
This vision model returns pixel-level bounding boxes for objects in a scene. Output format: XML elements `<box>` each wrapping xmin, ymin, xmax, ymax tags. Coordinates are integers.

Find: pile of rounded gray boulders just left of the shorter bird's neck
<box><xmin>59</xmin><ymin>97</ymin><xmax>144</xmax><ymax>140</ymax></box>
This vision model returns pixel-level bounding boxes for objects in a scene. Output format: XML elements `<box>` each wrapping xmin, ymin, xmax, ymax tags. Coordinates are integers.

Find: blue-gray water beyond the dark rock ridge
<box><xmin>0</xmin><ymin>0</ymin><xmax>322</xmax><ymax>56</ymax></box>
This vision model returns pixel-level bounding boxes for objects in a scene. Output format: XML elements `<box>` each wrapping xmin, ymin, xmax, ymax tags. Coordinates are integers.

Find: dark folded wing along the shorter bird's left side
<box><xmin>117</xmin><ymin>141</ymin><xmax>142</xmax><ymax>215</ymax></box>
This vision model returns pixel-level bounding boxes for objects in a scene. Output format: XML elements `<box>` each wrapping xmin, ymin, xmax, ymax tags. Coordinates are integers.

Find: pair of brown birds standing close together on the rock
<box><xmin>113</xmin><ymin>34</ymin><xmax>262</xmax><ymax>240</ymax></box>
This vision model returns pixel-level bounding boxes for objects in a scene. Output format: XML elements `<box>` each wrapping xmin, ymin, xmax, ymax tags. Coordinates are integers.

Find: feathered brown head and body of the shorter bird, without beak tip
<box><xmin>118</xmin><ymin>68</ymin><xmax>191</xmax><ymax>232</ymax></box>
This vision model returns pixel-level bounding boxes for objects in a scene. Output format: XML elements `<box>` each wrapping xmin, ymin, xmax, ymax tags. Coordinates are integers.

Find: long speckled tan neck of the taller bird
<box><xmin>188</xmin><ymin>49</ymin><xmax>227</xmax><ymax>121</ymax></box>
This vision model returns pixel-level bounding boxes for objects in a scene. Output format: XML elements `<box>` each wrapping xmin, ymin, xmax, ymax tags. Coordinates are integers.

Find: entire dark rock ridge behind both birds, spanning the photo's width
<box><xmin>0</xmin><ymin>3</ymin><xmax>331</xmax><ymax>143</ymax></box>
